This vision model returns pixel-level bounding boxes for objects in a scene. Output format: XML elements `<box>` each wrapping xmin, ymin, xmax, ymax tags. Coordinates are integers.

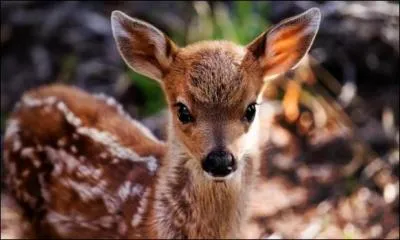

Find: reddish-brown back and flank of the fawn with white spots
<box><xmin>5</xmin><ymin>85</ymin><xmax>165</xmax><ymax>238</ymax></box>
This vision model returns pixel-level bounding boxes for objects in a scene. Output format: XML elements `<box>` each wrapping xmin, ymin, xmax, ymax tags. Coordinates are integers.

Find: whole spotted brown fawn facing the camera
<box><xmin>4</xmin><ymin>8</ymin><xmax>321</xmax><ymax>238</ymax></box>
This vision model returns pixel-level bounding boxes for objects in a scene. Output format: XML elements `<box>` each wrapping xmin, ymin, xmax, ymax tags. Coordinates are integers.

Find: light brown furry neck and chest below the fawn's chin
<box><xmin>153</xmin><ymin>127</ymin><xmax>253</xmax><ymax>238</ymax></box>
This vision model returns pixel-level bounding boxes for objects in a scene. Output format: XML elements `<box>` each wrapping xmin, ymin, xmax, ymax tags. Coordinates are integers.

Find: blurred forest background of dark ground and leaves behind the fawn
<box><xmin>1</xmin><ymin>1</ymin><xmax>399</xmax><ymax>239</ymax></box>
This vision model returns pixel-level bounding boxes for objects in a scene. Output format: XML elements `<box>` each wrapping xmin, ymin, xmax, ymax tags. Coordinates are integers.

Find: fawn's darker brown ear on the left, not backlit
<box><xmin>111</xmin><ymin>11</ymin><xmax>177</xmax><ymax>82</ymax></box>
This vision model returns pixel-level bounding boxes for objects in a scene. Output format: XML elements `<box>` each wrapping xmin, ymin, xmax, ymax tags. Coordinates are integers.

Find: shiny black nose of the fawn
<box><xmin>202</xmin><ymin>150</ymin><xmax>236</xmax><ymax>177</ymax></box>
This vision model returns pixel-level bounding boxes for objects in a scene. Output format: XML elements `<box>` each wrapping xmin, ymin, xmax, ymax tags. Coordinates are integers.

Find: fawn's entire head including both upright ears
<box><xmin>111</xmin><ymin>8</ymin><xmax>321</xmax><ymax>179</ymax></box>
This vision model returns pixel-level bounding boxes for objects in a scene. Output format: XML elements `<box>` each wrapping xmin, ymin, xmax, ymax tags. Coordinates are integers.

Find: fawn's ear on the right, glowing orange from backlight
<box><xmin>247</xmin><ymin>8</ymin><xmax>321</xmax><ymax>79</ymax></box>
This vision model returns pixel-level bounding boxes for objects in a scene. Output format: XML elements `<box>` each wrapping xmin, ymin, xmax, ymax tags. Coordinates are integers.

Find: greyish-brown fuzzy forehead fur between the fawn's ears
<box><xmin>174</xmin><ymin>41</ymin><xmax>246</xmax><ymax>105</ymax></box>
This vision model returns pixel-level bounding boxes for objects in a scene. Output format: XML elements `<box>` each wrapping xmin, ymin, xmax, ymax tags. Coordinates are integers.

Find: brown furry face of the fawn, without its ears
<box><xmin>164</xmin><ymin>42</ymin><xmax>263</xmax><ymax>177</ymax></box>
